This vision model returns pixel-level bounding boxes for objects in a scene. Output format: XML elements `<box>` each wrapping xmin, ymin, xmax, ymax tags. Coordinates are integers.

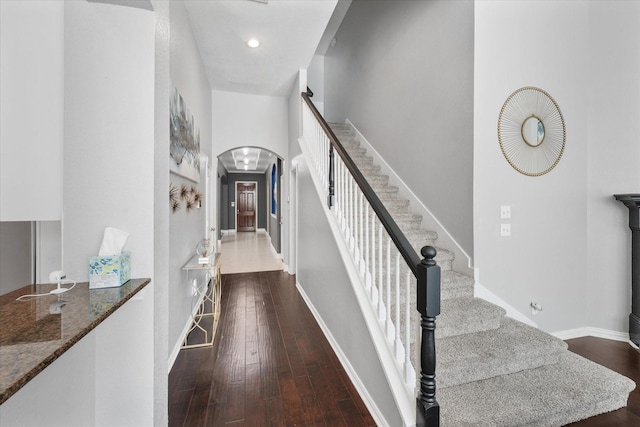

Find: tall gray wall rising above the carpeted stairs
<box><xmin>324</xmin><ymin>0</ymin><xmax>474</xmax><ymax>257</ymax></box>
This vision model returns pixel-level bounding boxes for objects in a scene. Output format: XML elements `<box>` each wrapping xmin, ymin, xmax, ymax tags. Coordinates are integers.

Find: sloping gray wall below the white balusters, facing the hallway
<box><xmin>296</xmin><ymin>161</ymin><xmax>402</xmax><ymax>426</ymax></box>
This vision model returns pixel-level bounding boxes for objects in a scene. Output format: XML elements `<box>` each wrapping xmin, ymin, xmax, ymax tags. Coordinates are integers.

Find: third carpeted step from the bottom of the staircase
<box><xmin>435</xmin><ymin>297</ymin><xmax>505</xmax><ymax>338</ymax></box>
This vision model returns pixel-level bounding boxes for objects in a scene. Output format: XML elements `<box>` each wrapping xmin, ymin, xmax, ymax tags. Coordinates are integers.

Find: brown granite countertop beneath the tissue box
<box><xmin>0</xmin><ymin>279</ymin><xmax>150</xmax><ymax>405</ymax></box>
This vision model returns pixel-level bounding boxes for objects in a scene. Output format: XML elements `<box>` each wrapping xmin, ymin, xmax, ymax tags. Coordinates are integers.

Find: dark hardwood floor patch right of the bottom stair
<box><xmin>567</xmin><ymin>337</ymin><xmax>640</xmax><ymax>427</ymax></box>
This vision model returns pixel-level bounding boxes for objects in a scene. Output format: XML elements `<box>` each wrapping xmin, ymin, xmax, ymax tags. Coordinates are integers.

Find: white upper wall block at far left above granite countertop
<box><xmin>0</xmin><ymin>0</ymin><xmax>64</xmax><ymax>221</ymax></box>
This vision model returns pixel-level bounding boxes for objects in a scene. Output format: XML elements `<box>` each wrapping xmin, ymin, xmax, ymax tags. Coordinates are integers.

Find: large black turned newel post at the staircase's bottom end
<box><xmin>416</xmin><ymin>246</ymin><xmax>440</xmax><ymax>427</ymax></box>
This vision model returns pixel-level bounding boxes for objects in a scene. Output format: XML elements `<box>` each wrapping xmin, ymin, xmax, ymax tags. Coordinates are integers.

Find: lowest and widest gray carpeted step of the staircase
<box><xmin>437</xmin><ymin>351</ymin><xmax>635</xmax><ymax>427</ymax></box>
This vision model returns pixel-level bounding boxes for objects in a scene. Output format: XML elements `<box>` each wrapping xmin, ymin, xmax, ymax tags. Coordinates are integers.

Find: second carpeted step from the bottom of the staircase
<box><xmin>436</xmin><ymin>317</ymin><xmax>567</xmax><ymax>390</ymax></box>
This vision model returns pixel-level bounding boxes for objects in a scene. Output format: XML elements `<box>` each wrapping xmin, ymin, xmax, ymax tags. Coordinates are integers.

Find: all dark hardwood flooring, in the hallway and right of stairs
<box><xmin>169</xmin><ymin>271</ymin><xmax>640</xmax><ymax>427</ymax></box>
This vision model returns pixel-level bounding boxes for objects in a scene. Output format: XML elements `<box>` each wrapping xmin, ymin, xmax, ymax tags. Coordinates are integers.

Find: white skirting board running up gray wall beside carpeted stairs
<box><xmin>345</xmin><ymin>119</ymin><xmax>474</xmax><ymax>277</ymax></box>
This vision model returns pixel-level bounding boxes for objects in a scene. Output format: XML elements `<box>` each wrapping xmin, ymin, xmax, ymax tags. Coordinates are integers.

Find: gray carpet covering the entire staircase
<box><xmin>330</xmin><ymin>124</ymin><xmax>635</xmax><ymax>427</ymax></box>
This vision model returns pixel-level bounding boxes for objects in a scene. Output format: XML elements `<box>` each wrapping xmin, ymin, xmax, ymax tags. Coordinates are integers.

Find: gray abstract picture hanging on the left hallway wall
<box><xmin>169</xmin><ymin>87</ymin><xmax>200</xmax><ymax>182</ymax></box>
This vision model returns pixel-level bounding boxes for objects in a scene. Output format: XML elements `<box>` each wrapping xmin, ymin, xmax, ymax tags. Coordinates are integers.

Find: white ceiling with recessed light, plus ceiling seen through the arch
<box><xmin>182</xmin><ymin>0</ymin><xmax>351</xmax><ymax>173</ymax></box>
